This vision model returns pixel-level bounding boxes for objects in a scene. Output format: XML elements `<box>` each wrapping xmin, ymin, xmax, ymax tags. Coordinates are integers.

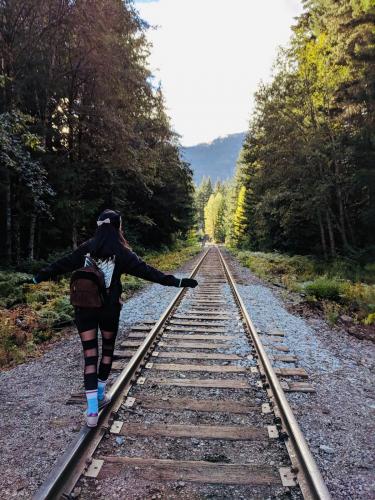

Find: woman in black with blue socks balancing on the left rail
<box><xmin>33</xmin><ymin>210</ymin><xmax>198</xmax><ymax>427</ymax></box>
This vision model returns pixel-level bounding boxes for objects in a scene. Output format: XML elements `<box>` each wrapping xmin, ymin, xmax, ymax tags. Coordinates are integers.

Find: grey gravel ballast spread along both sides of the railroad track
<box><xmin>0</xmin><ymin>248</ymin><xmax>375</xmax><ymax>500</ymax></box>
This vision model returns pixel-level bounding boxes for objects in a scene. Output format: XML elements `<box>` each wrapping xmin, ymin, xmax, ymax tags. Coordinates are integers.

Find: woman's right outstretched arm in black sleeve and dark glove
<box><xmin>122</xmin><ymin>249</ymin><xmax>198</xmax><ymax>288</ymax></box>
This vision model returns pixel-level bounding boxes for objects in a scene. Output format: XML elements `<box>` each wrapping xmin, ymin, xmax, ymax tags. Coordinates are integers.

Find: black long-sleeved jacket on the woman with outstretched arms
<box><xmin>35</xmin><ymin>240</ymin><xmax>180</xmax><ymax>303</ymax></box>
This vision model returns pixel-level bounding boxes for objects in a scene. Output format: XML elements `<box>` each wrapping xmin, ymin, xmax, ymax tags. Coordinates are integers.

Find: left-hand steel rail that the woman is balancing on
<box><xmin>32</xmin><ymin>249</ymin><xmax>209</xmax><ymax>500</ymax></box>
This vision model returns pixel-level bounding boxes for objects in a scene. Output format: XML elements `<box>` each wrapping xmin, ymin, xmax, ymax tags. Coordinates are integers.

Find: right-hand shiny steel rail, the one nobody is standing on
<box><xmin>217</xmin><ymin>247</ymin><xmax>331</xmax><ymax>500</ymax></box>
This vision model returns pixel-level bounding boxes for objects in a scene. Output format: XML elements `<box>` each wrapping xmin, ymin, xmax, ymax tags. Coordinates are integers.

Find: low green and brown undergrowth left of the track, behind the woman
<box><xmin>0</xmin><ymin>241</ymin><xmax>200</xmax><ymax>368</ymax></box>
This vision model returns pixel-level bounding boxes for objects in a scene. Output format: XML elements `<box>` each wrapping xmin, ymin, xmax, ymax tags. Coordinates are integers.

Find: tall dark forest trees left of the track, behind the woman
<box><xmin>0</xmin><ymin>0</ymin><xmax>193</xmax><ymax>265</ymax></box>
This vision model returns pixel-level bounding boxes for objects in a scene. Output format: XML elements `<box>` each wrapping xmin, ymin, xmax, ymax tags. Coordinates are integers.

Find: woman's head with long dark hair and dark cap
<box><xmin>90</xmin><ymin>209</ymin><xmax>130</xmax><ymax>259</ymax></box>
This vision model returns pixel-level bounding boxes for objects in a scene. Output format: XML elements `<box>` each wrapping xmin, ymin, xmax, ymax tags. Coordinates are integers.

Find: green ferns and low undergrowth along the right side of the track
<box><xmin>231</xmin><ymin>249</ymin><xmax>375</xmax><ymax>325</ymax></box>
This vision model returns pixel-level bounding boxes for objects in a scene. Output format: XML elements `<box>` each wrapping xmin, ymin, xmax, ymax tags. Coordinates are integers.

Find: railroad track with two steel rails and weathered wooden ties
<box><xmin>34</xmin><ymin>247</ymin><xmax>330</xmax><ymax>499</ymax></box>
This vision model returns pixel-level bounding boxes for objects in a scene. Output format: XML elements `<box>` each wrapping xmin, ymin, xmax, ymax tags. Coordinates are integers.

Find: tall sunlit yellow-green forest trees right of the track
<box><xmin>196</xmin><ymin>0</ymin><xmax>375</xmax><ymax>260</ymax></box>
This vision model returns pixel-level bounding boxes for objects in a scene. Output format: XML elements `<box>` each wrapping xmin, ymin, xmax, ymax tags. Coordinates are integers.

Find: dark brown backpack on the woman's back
<box><xmin>70</xmin><ymin>259</ymin><xmax>106</xmax><ymax>308</ymax></box>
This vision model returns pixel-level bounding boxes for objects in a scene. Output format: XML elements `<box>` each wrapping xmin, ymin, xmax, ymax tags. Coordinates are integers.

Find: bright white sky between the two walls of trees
<box><xmin>135</xmin><ymin>0</ymin><xmax>302</xmax><ymax>146</ymax></box>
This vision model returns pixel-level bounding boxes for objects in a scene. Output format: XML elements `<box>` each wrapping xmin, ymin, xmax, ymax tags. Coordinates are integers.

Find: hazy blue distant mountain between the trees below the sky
<box><xmin>181</xmin><ymin>132</ymin><xmax>246</xmax><ymax>184</ymax></box>
